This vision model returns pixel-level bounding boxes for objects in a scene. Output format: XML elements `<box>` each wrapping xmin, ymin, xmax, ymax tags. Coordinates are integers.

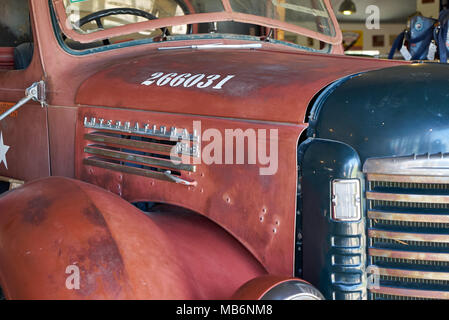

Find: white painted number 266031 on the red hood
<box><xmin>142</xmin><ymin>72</ymin><xmax>235</xmax><ymax>90</ymax></box>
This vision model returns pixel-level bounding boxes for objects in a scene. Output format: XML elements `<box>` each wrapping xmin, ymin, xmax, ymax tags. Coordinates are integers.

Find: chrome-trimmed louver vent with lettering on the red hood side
<box><xmin>83</xmin><ymin>118</ymin><xmax>199</xmax><ymax>185</ymax></box>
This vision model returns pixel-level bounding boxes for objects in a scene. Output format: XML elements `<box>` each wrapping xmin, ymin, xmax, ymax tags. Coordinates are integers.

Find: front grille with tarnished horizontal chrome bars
<box><xmin>364</xmin><ymin>154</ymin><xmax>449</xmax><ymax>300</ymax></box>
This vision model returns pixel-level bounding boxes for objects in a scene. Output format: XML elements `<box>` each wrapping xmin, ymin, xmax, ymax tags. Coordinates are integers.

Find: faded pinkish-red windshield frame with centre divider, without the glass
<box><xmin>52</xmin><ymin>0</ymin><xmax>343</xmax><ymax>45</ymax></box>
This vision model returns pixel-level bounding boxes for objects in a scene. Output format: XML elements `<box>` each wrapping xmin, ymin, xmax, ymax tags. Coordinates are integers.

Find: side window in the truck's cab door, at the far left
<box><xmin>0</xmin><ymin>0</ymin><xmax>34</xmax><ymax>70</ymax></box>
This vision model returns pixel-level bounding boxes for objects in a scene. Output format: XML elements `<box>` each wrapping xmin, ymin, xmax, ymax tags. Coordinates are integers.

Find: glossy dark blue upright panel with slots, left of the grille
<box><xmin>297</xmin><ymin>139</ymin><xmax>367</xmax><ymax>300</ymax></box>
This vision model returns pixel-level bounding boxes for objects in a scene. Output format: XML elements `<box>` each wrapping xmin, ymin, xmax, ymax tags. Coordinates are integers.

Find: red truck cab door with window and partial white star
<box><xmin>0</xmin><ymin>0</ymin><xmax>50</xmax><ymax>185</ymax></box>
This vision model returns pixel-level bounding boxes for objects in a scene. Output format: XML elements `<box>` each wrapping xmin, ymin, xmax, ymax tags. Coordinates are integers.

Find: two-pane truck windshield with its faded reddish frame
<box><xmin>53</xmin><ymin>0</ymin><xmax>338</xmax><ymax>44</ymax></box>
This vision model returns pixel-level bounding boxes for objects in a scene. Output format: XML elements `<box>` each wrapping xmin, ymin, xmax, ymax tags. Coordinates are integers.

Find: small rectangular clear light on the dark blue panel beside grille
<box><xmin>332</xmin><ymin>179</ymin><xmax>362</xmax><ymax>221</ymax></box>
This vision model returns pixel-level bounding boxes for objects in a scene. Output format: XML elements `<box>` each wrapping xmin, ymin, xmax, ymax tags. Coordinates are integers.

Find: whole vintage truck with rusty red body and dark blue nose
<box><xmin>0</xmin><ymin>0</ymin><xmax>449</xmax><ymax>300</ymax></box>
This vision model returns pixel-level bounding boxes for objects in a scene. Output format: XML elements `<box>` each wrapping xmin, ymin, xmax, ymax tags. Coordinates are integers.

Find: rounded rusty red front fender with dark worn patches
<box><xmin>0</xmin><ymin>178</ymin><xmax>266</xmax><ymax>299</ymax></box>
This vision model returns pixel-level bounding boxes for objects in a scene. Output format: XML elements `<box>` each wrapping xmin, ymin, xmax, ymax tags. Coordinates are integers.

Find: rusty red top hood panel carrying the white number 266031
<box><xmin>76</xmin><ymin>49</ymin><xmax>403</xmax><ymax>123</ymax></box>
